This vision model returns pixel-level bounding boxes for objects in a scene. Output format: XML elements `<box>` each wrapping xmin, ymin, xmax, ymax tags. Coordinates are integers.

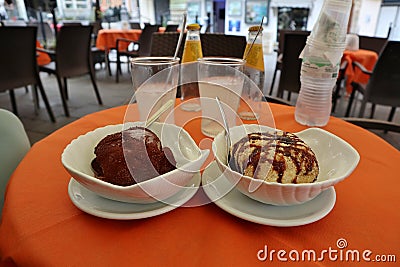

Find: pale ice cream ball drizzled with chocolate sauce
<box><xmin>230</xmin><ymin>131</ymin><xmax>319</xmax><ymax>184</ymax></box>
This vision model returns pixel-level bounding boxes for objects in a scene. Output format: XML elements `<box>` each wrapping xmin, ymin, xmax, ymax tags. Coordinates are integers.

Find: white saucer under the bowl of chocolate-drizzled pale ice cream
<box><xmin>202</xmin><ymin>162</ymin><xmax>336</xmax><ymax>226</ymax></box>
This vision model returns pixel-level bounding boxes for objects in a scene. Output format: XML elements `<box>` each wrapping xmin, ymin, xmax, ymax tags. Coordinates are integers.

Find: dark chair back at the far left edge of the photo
<box><xmin>0</xmin><ymin>26</ymin><xmax>39</xmax><ymax>92</ymax></box>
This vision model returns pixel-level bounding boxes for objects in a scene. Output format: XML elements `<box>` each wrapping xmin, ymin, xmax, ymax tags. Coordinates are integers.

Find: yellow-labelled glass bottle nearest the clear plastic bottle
<box><xmin>238</xmin><ymin>26</ymin><xmax>265</xmax><ymax>120</ymax></box>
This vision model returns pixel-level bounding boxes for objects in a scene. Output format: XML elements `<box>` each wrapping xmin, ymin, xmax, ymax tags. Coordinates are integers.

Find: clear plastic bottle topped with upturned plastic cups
<box><xmin>295</xmin><ymin>0</ymin><xmax>352</xmax><ymax>126</ymax></box>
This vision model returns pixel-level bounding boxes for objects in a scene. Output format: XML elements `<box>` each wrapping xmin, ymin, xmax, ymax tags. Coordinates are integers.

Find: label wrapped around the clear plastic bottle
<box><xmin>301</xmin><ymin>58</ymin><xmax>339</xmax><ymax>79</ymax></box>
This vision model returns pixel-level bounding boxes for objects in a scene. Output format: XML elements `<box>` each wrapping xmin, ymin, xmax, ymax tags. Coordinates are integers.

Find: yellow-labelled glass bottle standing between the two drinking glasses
<box><xmin>181</xmin><ymin>23</ymin><xmax>203</xmax><ymax>111</ymax></box>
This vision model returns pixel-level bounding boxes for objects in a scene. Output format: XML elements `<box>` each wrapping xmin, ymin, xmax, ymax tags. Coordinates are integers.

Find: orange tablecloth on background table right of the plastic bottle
<box><xmin>342</xmin><ymin>49</ymin><xmax>378</xmax><ymax>93</ymax></box>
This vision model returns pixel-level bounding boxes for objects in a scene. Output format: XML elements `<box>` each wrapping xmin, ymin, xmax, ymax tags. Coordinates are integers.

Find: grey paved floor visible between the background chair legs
<box><xmin>0</xmin><ymin>55</ymin><xmax>400</xmax><ymax>150</ymax></box>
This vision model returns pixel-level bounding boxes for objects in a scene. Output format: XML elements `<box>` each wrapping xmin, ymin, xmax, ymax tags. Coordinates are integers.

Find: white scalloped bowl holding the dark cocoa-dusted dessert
<box><xmin>61</xmin><ymin>122</ymin><xmax>210</xmax><ymax>203</ymax></box>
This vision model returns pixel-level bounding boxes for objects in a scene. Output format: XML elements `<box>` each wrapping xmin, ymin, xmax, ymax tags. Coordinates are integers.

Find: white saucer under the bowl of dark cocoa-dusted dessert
<box><xmin>68</xmin><ymin>173</ymin><xmax>201</xmax><ymax>220</ymax></box>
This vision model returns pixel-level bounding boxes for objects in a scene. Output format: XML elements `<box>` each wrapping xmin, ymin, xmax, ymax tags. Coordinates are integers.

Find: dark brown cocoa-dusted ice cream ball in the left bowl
<box><xmin>92</xmin><ymin>127</ymin><xmax>176</xmax><ymax>186</ymax></box>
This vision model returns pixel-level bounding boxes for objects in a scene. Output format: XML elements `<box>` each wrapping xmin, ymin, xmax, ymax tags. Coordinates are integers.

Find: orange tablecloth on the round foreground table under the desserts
<box><xmin>0</xmin><ymin>104</ymin><xmax>400</xmax><ymax>266</ymax></box>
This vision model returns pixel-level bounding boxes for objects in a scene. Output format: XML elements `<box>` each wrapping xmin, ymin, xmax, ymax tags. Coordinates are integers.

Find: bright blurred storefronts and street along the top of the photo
<box><xmin>0</xmin><ymin>0</ymin><xmax>400</xmax><ymax>50</ymax></box>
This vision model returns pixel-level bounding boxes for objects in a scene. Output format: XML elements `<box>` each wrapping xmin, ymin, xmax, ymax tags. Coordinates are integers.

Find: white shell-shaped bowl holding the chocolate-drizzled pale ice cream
<box><xmin>212</xmin><ymin>124</ymin><xmax>360</xmax><ymax>206</ymax></box>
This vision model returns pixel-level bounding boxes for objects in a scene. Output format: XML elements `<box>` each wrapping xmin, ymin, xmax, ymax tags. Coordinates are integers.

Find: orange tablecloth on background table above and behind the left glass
<box><xmin>96</xmin><ymin>29</ymin><xmax>142</xmax><ymax>50</ymax></box>
